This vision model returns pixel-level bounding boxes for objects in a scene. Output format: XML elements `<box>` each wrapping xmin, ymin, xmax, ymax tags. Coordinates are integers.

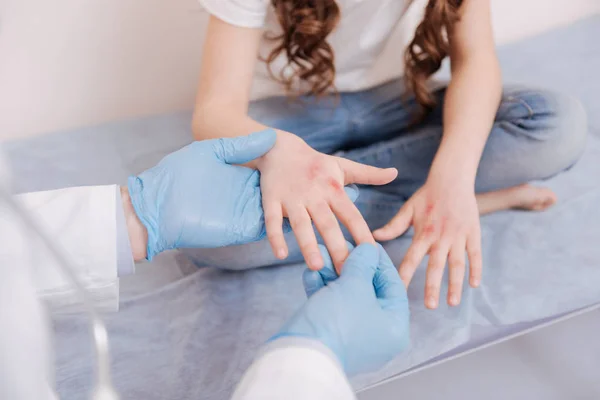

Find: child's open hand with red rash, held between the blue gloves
<box><xmin>257</xmin><ymin>132</ymin><xmax>398</xmax><ymax>272</ymax></box>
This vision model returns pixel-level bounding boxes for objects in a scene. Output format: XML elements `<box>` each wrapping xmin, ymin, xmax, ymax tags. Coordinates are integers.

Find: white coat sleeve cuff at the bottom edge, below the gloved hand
<box><xmin>232</xmin><ymin>337</ymin><xmax>356</xmax><ymax>400</ymax></box>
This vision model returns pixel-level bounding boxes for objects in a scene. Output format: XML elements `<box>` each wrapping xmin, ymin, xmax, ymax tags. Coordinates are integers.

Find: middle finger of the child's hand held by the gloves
<box><xmin>308</xmin><ymin>201</ymin><xmax>348</xmax><ymax>273</ymax></box>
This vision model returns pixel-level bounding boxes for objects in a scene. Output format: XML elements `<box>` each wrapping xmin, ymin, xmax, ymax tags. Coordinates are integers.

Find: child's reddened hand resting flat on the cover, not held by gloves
<box><xmin>374</xmin><ymin>178</ymin><xmax>481</xmax><ymax>308</ymax></box>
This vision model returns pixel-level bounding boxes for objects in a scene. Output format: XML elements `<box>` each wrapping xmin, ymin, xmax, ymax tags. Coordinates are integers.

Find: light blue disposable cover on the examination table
<box><xmin>4</xmin><ymin>17</ymin><xmax>600</xmax><ymax>400</ymax></box>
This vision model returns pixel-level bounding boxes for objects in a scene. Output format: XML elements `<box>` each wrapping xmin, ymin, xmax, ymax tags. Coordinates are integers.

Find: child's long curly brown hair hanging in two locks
<box><xmin>265</xmin><ymin>0</ymin><xmax>462</xmax><ymax>111</ymax></box>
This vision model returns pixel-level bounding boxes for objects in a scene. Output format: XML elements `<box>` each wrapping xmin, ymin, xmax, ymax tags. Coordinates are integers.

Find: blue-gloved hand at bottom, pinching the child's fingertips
<box><xmin>271</xmin><ymin>244</ymin><xmax>410</xmax><ymax>375</ymax></box>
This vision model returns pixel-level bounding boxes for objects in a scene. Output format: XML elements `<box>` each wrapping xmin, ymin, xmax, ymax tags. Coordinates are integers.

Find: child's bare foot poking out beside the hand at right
<box><xmin>477</xmin><ymin>184</ymin><xmax>556</xmax><ymax>215</ymax></box>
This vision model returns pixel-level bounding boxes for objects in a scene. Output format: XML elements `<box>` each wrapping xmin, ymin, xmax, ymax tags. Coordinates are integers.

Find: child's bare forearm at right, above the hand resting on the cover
<box><xmin>433</xmin><ymin>0</ymin><xmax>502</xmax><ymax>181</ymax></box>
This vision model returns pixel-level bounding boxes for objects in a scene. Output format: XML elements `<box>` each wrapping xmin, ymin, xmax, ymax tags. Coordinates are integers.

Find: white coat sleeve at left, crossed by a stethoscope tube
<box><xmin>11</xmin><ymin>185</ymin><xmax>133</xmax><ymax>312</ymax></box>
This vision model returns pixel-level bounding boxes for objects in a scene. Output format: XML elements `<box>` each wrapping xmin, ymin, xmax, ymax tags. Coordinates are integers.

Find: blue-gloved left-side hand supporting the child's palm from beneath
<box><xmin>125</xmin><ymin>130</ymin><xmax>284</xmax><ymax>260</ymax></box>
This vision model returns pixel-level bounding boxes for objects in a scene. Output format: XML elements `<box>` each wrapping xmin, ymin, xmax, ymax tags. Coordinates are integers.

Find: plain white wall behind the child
<box><xmin>0</xmin><ymin>0</ymin><xmax>600</xmax><ymax>139</ymax></box>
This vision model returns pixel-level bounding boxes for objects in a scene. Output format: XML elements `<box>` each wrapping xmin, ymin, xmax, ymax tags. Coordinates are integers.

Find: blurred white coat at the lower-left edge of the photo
<box><xmin>0</xmin><ymin>192</ymin><xmax>57</xmax><ymax>400</ymax></box>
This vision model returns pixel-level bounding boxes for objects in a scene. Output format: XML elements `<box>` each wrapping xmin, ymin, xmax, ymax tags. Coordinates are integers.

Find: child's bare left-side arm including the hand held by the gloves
<box><xmin>193</xmin><ymin>14</ymin><xmax>397</xmax><ymax>269</ymax></box>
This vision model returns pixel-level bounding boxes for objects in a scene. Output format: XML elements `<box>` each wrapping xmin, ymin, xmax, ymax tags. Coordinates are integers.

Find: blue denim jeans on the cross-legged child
<box><xmin>186</xmin><ymin>81</ymin><xmax>587</xmax><ymax>269</ymax></box>
